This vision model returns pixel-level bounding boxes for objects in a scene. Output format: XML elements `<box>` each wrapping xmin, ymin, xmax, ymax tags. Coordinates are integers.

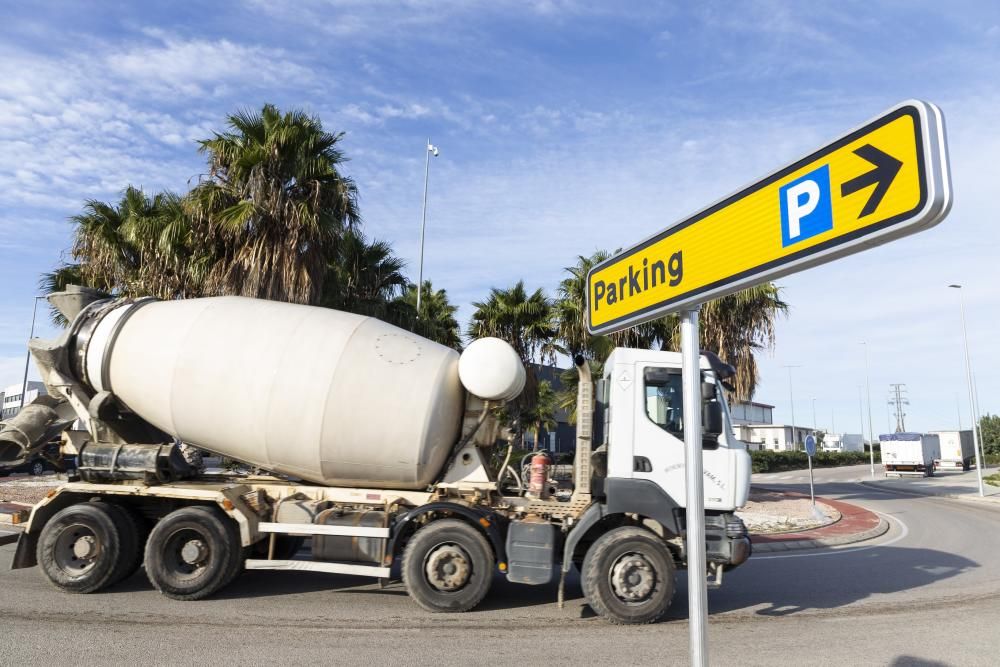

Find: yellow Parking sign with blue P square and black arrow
<box><xmin>587</xmin><ymin>100</ymin><xmax>951</xmax><ymax>334</ymax></box>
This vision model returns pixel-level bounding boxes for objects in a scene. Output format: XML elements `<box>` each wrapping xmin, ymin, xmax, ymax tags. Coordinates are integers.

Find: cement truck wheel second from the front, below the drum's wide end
<box><xmin>402</xmin><ymin>519</ymin><xmax>494</xmax><ymax>612</ymax></box>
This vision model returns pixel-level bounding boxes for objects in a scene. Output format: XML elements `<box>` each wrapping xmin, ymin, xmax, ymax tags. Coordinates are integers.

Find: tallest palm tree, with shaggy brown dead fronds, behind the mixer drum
<box><xmin>191</xmin><ymin>104</ymin><xmax>360</xmax><ymax>303</ymax></box>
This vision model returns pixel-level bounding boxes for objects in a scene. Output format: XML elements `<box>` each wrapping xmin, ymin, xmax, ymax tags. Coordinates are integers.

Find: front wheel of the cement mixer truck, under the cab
<box><xmin>581</xmin><ymin>526</ymin><xmax>675</xmax><ymax>625</ymax></box>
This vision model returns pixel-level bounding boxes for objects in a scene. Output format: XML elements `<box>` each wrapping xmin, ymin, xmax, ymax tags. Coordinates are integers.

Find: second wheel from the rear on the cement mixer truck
<box><xmin>145</xmin><ymin>507</ymin><xmax>242</xmax><ymax>600</ymax></box>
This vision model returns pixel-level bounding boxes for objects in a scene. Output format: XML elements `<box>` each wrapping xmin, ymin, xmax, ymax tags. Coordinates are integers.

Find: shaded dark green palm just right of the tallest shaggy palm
<box><xmin>320</xmin><ymin>230</ymin><xmax>409</xmax><ymax>321</ymax></box>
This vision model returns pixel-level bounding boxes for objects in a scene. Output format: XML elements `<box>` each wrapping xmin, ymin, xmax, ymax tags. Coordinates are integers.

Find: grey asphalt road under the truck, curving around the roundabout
<box><xmin>0</xmin><ymin>466</ymin><xmax>1000</xmax><ymax>666</ymax></box>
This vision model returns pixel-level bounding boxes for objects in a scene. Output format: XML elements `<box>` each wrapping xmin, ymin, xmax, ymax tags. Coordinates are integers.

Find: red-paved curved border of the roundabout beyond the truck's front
<box><xmin>750</xmin><ymin>487</ymin><xmax>889</xmax><ymax>553</ymax></box>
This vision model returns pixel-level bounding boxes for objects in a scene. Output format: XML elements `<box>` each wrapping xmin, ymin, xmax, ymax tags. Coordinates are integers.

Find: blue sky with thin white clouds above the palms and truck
<box><xmin>0</xmin><ymin>0</ymin><xmax>1000</xmax><ymax>432</ymax></box>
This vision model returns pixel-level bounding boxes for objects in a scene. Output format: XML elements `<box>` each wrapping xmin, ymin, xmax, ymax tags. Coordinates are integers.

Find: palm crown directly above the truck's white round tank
<box><xmin>469</xmin><ymin>280</ymin><xmax>558</xmax><ymax>363</ymax></box>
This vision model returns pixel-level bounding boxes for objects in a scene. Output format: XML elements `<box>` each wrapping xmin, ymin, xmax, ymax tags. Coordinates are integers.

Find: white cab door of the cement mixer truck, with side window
<box><xmin>632</xmin><ymin>362</ymin><xmax>735</xmax><ymax>509</ymax></box>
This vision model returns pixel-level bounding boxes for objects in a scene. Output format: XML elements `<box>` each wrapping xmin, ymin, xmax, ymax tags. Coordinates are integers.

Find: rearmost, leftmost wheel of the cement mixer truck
<box><xmin>36</xmin><ymin>503</ymin><xmax>122</xmax><ymax>593</ymax></box>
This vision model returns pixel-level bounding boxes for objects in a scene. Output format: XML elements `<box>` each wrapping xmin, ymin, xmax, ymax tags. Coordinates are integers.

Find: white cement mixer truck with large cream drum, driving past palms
<box><xmin>0</xmin><ymin>288</ymin><xmax>751</xmax><ymax>623</ymax></box>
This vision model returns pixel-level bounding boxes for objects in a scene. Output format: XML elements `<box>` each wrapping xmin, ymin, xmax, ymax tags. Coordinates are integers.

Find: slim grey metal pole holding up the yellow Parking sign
<box><xmin>681</xmin><ymin>309</ymin><xmax>708</xmax><ymax>667</ymax></box>
